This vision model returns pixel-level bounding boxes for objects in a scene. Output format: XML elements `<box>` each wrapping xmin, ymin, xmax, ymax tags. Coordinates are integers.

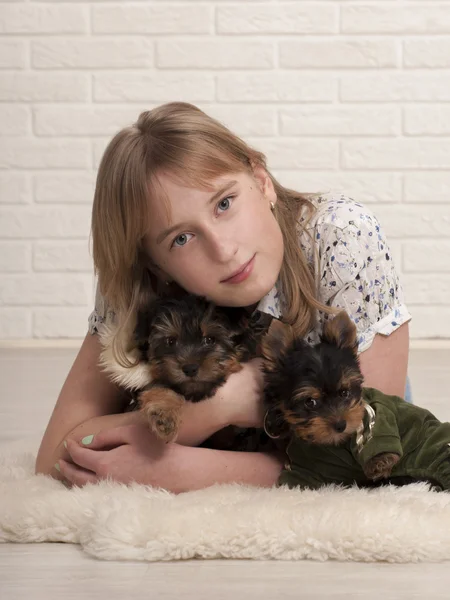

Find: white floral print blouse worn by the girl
<box><xmin>89</xmin><ymin>194</ymin><xmax>411</xmax><ymax>352</ymax></box>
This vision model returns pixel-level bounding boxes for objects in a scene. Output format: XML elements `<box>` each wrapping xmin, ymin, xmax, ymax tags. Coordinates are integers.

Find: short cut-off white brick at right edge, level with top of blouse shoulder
<box><xmin>403</xmin><ymin>171</ymin><xmax>450</xmax><ymax>204</ymax></box>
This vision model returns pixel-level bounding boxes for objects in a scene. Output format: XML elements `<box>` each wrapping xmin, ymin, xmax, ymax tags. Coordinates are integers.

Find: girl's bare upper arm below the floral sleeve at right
<box><xmin>359</xmin><ymin>323</ymin><xmax>409</xmax><ymax>398</ymax></box>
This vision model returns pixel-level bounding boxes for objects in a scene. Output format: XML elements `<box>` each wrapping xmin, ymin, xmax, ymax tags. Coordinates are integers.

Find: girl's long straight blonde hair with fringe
<box><xmin>91</xmin><ymin>102</ymin><xmax>331</xmax><ymax>366</ymax></box>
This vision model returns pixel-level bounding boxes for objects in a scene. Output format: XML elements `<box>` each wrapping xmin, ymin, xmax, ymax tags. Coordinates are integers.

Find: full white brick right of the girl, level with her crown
<box><xmin>279</xmin><ymin>106</ymin><xmax>401</xmax><ymax>136</ymax></box>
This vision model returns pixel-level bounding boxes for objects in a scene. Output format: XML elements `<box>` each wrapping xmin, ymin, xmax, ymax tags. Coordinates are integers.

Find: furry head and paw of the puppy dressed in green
<box><xmin>262</xmin><ymin>312</ymin><xmax>400</xmax><ymax>488</ymax></box>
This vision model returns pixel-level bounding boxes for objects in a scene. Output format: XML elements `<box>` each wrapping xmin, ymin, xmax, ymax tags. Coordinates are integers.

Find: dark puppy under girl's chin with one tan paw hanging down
<box><xmin>134</xmin><ymin>296</ymin><xmax>256</xmax><ymax>442</ymax></box>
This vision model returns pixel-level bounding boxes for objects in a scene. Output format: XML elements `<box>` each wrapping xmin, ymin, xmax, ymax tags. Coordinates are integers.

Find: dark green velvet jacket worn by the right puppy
<box><xmin>278</xmin><ymin>388</ymin><xmax>450</xmax><ymax>490</ymax></box>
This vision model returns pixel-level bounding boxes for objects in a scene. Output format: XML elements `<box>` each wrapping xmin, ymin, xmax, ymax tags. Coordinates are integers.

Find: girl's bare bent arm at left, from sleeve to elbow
<box><xmin>35</xmin><ymin>333</ymin><xmax>130</xmax><ymax>476</ymax></box>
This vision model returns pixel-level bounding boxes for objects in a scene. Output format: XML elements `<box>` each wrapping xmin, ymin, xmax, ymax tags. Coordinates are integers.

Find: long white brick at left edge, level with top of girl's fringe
<box><xmin>0</xmin><ymin>137</ymin><xmax>90</xmax><ymax>169</ymax></box>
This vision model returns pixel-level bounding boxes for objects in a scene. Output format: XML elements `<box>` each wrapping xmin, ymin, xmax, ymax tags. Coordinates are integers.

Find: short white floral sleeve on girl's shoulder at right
<box><xmin>315</xmin><ymin>198</ymin><xmax>411</xmax><ymax>352</ymax></box>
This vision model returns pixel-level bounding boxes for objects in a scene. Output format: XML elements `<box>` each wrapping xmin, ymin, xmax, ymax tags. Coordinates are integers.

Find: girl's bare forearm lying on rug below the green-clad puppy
<box><xmin>169</xmin><ymin>447</ymin><xmax>283</xmax><ymax>493</ymax></box>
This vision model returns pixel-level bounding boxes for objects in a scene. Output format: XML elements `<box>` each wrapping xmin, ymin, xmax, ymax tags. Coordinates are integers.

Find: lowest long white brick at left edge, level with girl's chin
<box><xmin>0</xmin><ymin>273</ymin><xmax>92</xmax><ymax>307</ymax></box>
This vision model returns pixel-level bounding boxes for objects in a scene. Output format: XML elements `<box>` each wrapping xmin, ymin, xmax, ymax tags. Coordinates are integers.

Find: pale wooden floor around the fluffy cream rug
<box><xmin>0</xmin><ymin>349</ymin><xmax>450</xmax><ymax>600</ymax></box>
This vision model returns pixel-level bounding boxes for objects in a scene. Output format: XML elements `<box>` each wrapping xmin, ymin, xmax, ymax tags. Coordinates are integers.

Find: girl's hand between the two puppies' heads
<box><xmin>217</xmin><ymin>358</ymin><xmax>264</xmax><ymax>427</ymax></box>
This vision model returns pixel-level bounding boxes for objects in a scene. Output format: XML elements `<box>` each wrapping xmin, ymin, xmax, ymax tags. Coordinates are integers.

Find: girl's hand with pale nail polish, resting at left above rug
<box><xmin>59</xmin><ymin>424</ymin><xmax>182</xmax><ymax>491</ymax></box>
